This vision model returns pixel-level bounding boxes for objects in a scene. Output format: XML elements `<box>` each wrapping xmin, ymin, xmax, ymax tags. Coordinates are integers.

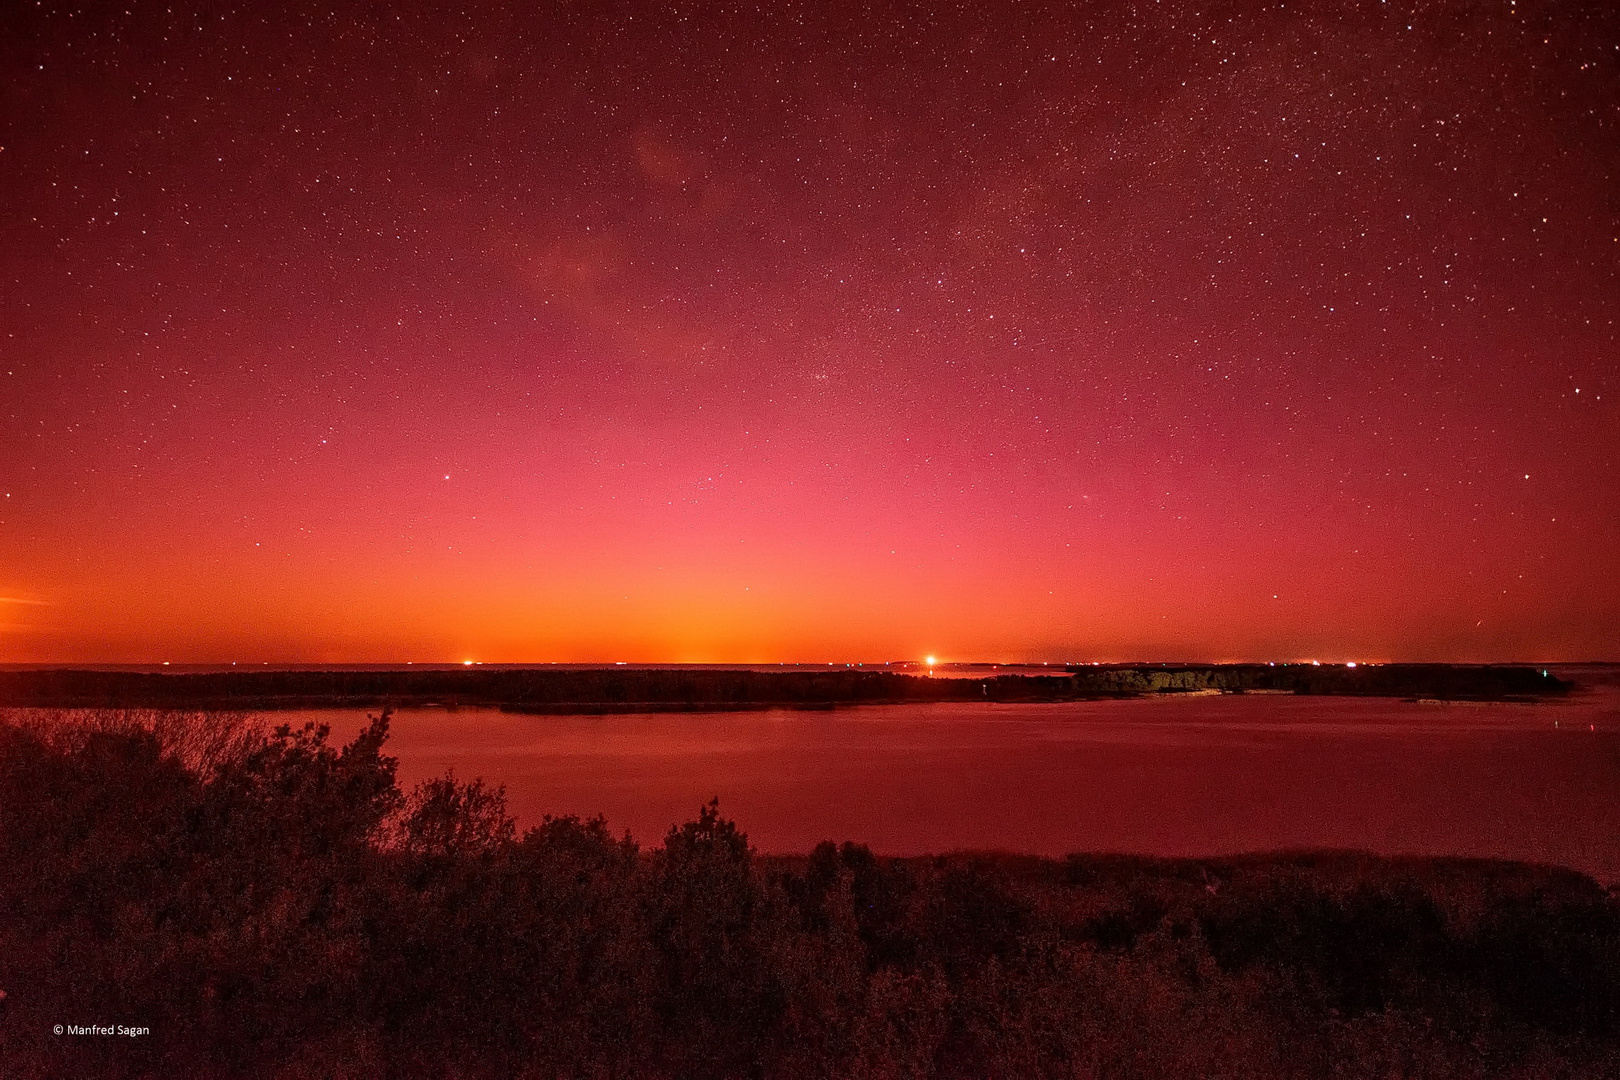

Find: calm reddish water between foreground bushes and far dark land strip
<box><xmin>291</xmin><ymin>688</ymin><xmax>1620</xmax><ymax>881</ymax></box>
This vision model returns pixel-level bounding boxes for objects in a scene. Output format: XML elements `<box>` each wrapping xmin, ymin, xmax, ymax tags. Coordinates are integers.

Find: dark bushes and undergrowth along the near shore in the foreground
<box><xmin>0</xmin><ymin>711</ymin><xmax>1620</xmax><ymax>1080</ymax></box>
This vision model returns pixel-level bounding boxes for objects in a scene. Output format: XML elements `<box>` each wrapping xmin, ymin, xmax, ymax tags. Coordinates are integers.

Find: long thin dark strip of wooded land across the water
<box><xmin>0</xmin><ymin>664</ymin><xmax>1571</xmax><ymax>712</ymax></box>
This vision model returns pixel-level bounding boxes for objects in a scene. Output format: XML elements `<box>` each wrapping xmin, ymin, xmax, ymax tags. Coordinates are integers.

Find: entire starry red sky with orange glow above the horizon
<box><xmin>0</xmin><ymin>0</ymin><xmax>1620</xmax><ymax>662</ymax></box>
